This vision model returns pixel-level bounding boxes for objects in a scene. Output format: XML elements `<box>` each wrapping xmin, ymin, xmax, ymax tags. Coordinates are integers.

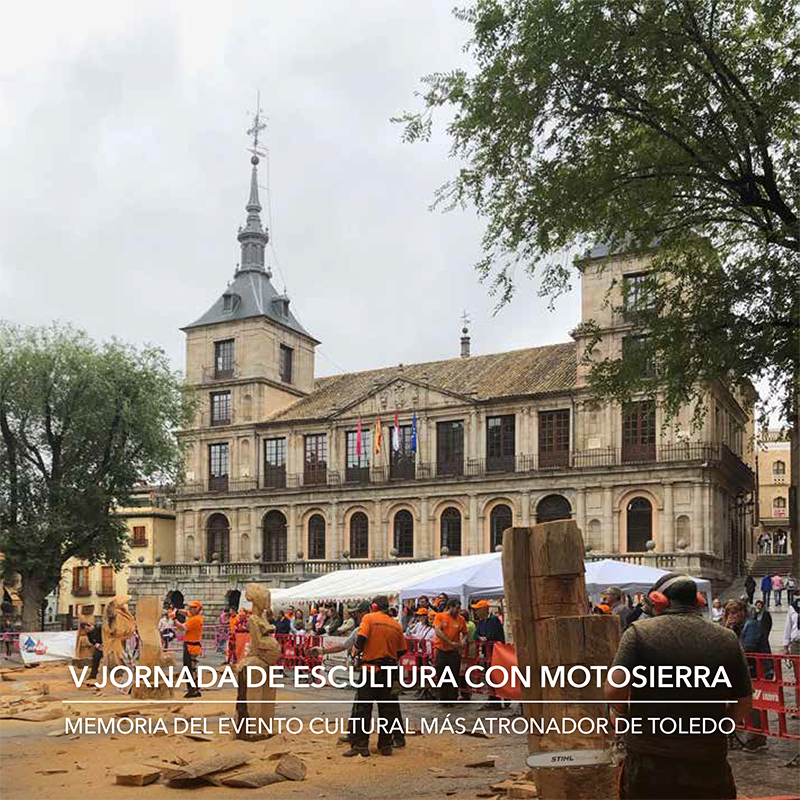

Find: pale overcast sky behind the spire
<box><xmin>0</xmin><ymin>0</ymin><xmax>579</xmax><ymax>375</ymax></box>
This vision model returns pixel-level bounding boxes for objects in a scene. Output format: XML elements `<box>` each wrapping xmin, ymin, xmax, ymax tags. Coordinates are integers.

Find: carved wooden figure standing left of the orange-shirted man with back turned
<box><xmin>236</xmin><ymin>583</ymin><xmax>281</xmax><ymax>742</ymax></box>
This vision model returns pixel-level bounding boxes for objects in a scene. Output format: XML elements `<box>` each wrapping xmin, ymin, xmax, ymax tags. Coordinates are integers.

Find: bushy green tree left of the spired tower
<box><xmin>0</xmin><ymin>323</ymin><xmax>193</xmax><ymax>630</ymax></box>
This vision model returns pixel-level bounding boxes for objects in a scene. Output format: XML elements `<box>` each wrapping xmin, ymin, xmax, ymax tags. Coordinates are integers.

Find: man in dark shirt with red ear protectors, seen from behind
<box><xmin>605</xmin><ymin>573</ymin><xmax>753</xmax><ymax>800</ymax></box>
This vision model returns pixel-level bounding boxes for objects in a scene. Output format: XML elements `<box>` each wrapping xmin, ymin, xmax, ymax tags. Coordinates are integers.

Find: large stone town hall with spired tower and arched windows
<box><xmin>134</xmin><ymin>152</ymin><xmax>754</xmax><ymax>612</ymax></box>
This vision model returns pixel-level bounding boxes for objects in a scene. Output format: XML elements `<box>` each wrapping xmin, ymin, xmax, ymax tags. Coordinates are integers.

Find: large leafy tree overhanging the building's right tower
<box><xmin>397</xmin><ymin>0</ymin><xmax>800</xmax><ymax>566</ymax></box>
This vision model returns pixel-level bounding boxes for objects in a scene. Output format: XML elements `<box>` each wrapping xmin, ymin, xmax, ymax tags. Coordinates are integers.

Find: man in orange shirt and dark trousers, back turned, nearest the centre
<box><xmin>344</xmin><ymin>595</ymin><xmax>406</xmax><ymax>758</ymax></box>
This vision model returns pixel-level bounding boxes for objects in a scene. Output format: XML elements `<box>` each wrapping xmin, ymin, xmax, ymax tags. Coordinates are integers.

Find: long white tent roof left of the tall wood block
<box><xmin>262</xmin><ymin>553</ymin><xmax>503</xmax><ymax>609</ymax></box>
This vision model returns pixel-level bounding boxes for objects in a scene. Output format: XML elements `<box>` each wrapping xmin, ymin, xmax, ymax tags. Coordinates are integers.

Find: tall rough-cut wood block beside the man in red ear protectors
<box><xmin>503</xmin><ymin>520</ymin><xmax>620</xmax><ymax>800</ymax></box>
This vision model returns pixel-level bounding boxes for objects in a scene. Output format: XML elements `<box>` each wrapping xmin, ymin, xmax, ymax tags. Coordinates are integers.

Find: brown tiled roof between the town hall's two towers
<box><xmin>269</xmin><ymin>342</ymin><xmax>576</xmax><ymax>422</ymax></box>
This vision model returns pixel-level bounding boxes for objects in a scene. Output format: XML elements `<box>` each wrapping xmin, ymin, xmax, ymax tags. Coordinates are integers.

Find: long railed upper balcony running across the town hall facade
<box><xmin>180</xmin><ymin>442</ymin><xmax>754</xmax><ymax>494</ymax></box>
